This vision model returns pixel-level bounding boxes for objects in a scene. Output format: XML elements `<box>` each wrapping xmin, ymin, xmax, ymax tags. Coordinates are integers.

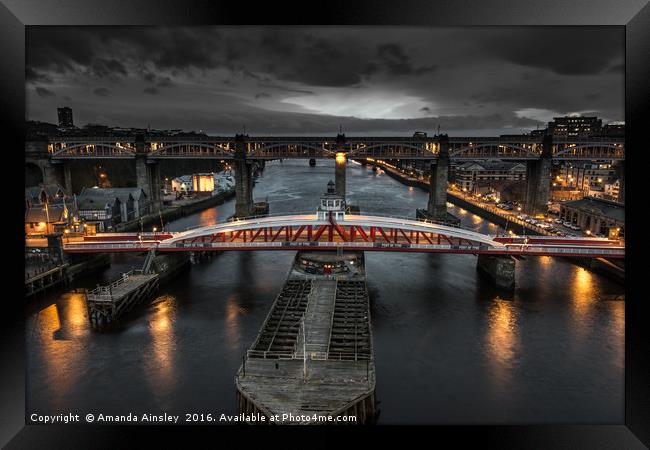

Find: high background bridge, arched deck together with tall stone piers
<box><xmin>26</xmin><ymin>134</ymin><xmax>625</xmax><ymax>220</ymax></box>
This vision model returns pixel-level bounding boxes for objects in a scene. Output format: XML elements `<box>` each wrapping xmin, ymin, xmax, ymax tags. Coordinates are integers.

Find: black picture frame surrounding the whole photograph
<box><xmin>0</xmin><ymin>0</ymin><xmax>650</xmax><ymax>449</ymax></box>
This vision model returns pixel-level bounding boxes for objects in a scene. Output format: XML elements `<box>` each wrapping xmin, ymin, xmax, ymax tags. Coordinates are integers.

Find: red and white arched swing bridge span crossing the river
<box><xmin>63</xmin><ymin>214</ymin><xmax>625</xmax><ymax>258</ymax></box>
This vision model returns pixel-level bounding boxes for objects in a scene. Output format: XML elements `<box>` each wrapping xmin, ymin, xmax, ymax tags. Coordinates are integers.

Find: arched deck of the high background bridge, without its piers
<box><xmin>48</xmin><ymin>135</ymin><xmax>625</xmax><ymax>161</ymax></box>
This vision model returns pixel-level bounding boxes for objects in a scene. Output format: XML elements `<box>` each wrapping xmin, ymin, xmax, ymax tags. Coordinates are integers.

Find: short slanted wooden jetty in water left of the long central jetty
<box><xmin>86</xmin><ymin>270</ymin><xmax>159</xmax><ymax>328</ymax></box>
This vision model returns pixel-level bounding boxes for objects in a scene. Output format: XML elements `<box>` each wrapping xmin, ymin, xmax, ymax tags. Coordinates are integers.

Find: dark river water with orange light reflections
<box><xmin>26</xmin><ymin>161</ymin><xmax>625</xmax><ymax>424</ymax></box>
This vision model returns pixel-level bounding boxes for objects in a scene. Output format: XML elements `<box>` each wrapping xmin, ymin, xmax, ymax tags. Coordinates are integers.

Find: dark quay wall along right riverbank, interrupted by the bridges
<box><xmin>369</xmin><ymin>162</ymin><xmax>625</xmax><ymax>283</ymax></box>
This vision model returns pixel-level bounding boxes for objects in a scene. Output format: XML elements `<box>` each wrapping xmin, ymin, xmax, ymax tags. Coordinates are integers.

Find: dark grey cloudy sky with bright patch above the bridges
<box><xmin>26</xmin><ymin>27</ymin><xmax>624</xmax><ymax>136</ymax></box>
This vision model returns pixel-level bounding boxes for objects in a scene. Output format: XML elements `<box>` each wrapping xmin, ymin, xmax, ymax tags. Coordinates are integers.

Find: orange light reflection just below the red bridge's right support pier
<box><xmin>486</xmin><ymin>297</ymin><xmax>519</xmax><ymax>387</ymax></box>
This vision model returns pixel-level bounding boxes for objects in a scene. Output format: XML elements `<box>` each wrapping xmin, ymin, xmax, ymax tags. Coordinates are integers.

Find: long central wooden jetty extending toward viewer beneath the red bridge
<box><xmin>235</xmin><ymin>252</ymin><xmax>378</xmax><ymax>424</ymax></box>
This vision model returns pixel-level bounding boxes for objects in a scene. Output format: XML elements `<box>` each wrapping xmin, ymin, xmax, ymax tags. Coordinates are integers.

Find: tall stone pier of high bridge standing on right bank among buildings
<box><xmin>525</xmin><ymin>135</ymin><xmax>553</xmax><ymax>215</ymax></box>
